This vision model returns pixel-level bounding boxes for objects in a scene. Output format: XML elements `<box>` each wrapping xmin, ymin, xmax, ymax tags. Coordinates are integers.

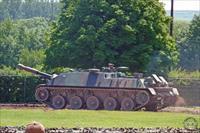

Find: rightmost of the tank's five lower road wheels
<box><xmin>121</xmin><ymin>97</ymin><xmax>135</xmax><ymax>111</ymax></box>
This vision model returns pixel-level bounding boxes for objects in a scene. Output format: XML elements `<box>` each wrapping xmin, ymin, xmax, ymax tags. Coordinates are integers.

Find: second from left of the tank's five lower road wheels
<box><xmin>69</xmin><ymin>96</ymin><xmax>83</xmax><ymax>109</ymax></box>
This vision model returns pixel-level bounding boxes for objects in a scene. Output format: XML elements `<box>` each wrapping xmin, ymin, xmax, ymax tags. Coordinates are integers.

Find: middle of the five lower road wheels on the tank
<box><xmin>86</xmin><ymin>96</ymin><xmax>100</xmax><ymax>110</ymax></box>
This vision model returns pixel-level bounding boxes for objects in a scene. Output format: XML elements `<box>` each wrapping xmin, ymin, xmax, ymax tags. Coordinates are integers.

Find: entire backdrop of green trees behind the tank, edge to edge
<box><xmin>0</xmin><ymin>0</ymin><xmax>200</xmax><ymax>76</ymax></box>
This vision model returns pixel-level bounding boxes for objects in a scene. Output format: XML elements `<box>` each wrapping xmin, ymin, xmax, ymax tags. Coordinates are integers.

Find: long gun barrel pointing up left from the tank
<box><xmin>17</xmin><ymin>64</ymin><xmax>52</xmax><ymax>79</ymax></box>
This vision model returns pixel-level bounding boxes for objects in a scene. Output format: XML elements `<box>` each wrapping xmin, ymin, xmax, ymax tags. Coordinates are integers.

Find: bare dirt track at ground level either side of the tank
<box><xmin>0</xmin><ymin>104</ymin><xmax>200</xmax><ymax>115</ymax></box>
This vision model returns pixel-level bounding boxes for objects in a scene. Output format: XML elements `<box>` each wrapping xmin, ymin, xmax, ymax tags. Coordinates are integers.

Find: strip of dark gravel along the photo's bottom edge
<box><xmin>0</xmin><ymin>127</ymin><xmax>200</xmax><ymax>133</ymax></box>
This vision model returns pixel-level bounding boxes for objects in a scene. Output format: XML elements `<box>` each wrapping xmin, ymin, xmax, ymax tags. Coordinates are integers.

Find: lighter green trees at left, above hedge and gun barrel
<box><xmin>0</xmin><ymin>18</ymin><xmax>48</xmax><ymax>68</ymax></box>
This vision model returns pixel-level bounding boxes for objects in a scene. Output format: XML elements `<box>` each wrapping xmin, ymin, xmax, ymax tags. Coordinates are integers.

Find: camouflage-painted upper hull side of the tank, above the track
<box><xmin>49</xmin><ymin>72</ymin><xmax>145</xmax><ymax>88</ymax></box>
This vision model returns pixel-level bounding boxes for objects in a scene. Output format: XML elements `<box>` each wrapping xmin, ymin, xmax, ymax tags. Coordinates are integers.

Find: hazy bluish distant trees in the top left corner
<box><xmin>0</xmin><ymin>0</ymin><xmax>61</xmax><ymax>21</ymax></box>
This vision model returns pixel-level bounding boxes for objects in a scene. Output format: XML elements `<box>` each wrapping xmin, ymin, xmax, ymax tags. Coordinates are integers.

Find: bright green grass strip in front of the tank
<box><xmin>0</xmin><ymin>109</ymin><xmax>200</xmax><ymax>128</ymax></box>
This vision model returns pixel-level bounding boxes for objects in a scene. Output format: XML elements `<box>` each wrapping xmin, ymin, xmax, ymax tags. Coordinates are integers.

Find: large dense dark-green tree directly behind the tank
<box><xmin>46</xmin><ymin>0</ymin><xmax>177</xmax><ymax>71</ymax></box>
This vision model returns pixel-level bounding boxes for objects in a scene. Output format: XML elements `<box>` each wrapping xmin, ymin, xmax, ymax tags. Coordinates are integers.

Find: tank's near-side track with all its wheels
<box><xmin>35</xmin><ymin>85</ymin><xmax>155</xmax><ymax>111</ymax></box>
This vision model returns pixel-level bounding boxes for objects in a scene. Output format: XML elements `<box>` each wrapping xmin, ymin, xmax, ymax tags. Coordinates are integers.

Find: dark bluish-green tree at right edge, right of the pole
<box><xmin>180</xmin><ymin>15</ymin><xmax>200</xmax><ymax>70</ymax></box>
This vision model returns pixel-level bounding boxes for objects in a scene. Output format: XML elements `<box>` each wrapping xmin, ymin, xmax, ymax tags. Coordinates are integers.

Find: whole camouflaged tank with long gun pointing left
<box><xmin>18</xmin><ymin>64</ymin><xmax>179</xmax><ymax>111</ymax></box>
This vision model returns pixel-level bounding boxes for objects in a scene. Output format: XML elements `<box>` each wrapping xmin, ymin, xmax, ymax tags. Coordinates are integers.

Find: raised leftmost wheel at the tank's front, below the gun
<box><xmin>35</xmin><ymin>88</ymin><xmax>49</xmax><ymax>102</ymax></box>
